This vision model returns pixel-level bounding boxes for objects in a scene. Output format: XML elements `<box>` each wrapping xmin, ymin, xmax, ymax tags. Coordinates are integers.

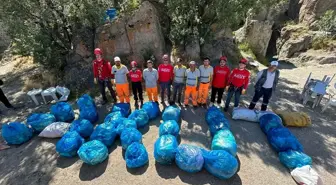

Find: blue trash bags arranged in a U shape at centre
<box><xmin>154</xmin><ymin>106</ymin><xmax>239</xmax><ymax>179</ymax></box>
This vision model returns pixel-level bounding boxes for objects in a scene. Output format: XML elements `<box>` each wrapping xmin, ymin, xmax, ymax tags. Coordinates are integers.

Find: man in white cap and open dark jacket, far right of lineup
<box><xmin>249</xmin><ymin>61</ymin><xmax>280</xmax><ymax>111</ymax></box>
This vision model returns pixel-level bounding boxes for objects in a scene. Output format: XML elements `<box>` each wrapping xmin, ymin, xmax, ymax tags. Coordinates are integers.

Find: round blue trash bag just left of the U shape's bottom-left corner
<box><xmin>125</xmin><ymin>143</ymin><xmax>148</xmax><ymax>168</ymax></box>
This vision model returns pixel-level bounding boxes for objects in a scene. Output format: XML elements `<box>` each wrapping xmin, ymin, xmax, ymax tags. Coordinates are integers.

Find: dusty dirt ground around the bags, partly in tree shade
<box><xmin>0</xmin><ymin>59</ymin><xmax>336</xmax><ymax>185</ymax></box>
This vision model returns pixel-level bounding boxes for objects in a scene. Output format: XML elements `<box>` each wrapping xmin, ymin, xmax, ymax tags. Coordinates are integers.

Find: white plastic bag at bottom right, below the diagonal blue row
<box><xmin>291</xmin><ymin>165</ymin><xmax>323</xmax><ymax>185</ymax></box>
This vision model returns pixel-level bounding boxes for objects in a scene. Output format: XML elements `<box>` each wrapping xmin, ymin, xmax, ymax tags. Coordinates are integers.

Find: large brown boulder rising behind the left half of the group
<box><xmin>95</xmin><ymin>1</ymin><xmax>165</xmax><ymax>66</ymax></box>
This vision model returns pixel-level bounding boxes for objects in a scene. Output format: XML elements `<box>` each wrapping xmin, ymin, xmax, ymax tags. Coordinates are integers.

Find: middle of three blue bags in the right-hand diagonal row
<box><xmin>267</xmin><ymin>127</ymin><xmax>303</xmax><ymax>152</ymax></box>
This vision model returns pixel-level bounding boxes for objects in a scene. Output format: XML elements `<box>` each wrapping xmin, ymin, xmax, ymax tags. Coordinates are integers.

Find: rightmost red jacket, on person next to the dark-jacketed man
<box><xmin>228</xmin><ymin>68</ymin><xmax>250</xmax><ymax>89</ymax></box>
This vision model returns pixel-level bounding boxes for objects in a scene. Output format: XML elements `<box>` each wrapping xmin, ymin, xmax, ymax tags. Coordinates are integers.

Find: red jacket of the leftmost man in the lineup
<box><xmin>93</xmin><ymin>59</ymin><xmax>114</xmax><ymax>80</ymax></box>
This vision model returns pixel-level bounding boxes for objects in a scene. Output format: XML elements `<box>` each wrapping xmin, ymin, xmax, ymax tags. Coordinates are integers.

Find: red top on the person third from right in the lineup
<box><xmin>212</xmin><ymin>66</ymin><xmax>230</xmax><ymax>88</ymax></box>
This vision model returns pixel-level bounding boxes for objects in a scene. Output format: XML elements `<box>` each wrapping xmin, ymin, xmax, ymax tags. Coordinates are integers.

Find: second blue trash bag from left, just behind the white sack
<box><xmin>27</xmin><ymin>113</ymin><xmax>56</xmax><ymax>132</ymax></box>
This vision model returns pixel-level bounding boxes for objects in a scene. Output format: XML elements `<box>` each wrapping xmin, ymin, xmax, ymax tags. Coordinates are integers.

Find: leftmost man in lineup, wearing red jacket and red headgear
<box><xmin>93</xmin><ymin>48</ymin><xmax>117</xmax><ymax>105</ymax></box>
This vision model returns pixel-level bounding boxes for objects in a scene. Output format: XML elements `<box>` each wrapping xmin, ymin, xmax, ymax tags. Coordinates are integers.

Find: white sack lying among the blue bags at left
<box><xmin>39</xmin><ymin>122</ymin><xmax>71</xmax><ymax>138</ymax></box>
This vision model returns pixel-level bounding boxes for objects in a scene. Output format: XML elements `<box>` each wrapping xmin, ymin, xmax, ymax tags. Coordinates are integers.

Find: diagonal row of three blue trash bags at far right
<box><xmin>259</xmin><ymin>114</ymin><xmax>312</xmax><ymax>169</ymax></box>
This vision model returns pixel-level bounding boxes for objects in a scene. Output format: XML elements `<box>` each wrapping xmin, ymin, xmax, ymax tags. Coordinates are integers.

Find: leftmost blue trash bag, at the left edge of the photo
<box><xmin>1</xmin><ymin>122</ymin><xmax>33</xmax><ymax>145</ymax></box>
